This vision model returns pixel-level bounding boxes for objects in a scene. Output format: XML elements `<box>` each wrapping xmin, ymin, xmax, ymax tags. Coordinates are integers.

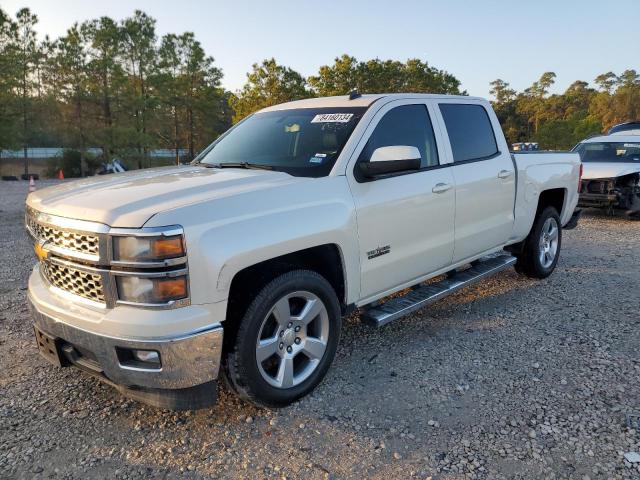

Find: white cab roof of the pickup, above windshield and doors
<box><xmin>260</xmin><ymin>93</ymin><xmax>484</xmax><ymax>112</ymax></box>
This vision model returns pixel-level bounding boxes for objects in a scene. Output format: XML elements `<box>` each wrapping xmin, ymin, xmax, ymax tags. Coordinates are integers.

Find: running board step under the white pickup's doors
<box><xmin>361</xmin><ymin>254</ymin><xmax>516</xmax><ymax>327</ymax></box>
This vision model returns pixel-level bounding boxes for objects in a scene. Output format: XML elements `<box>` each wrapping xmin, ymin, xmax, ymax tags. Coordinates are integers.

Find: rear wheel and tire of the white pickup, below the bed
<box><xmin>515</xmin><ymin>207</ymin><xmax>562</xmax><ymax>278</ymax></box>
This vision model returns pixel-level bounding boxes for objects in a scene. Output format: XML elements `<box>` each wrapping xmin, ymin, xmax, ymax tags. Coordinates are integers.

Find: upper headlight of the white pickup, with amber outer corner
<box><xmin>113</xmin><ymin>235</ymin><xmax>186</xmax><ymax>262</ymax></box>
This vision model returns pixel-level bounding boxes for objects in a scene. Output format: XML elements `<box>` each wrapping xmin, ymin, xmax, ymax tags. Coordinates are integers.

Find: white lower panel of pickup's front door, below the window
<box><xmin>352</xmin><ymin>167</ymin><xmax>455</xmax><ymax>298</ymax></box>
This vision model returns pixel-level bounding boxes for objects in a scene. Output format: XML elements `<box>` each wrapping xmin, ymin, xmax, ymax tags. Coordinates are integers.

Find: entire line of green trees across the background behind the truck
<box><xmin>0</xmin><ymin>8</ymin><xmax>640</xmax><ymax>175</ymax></box>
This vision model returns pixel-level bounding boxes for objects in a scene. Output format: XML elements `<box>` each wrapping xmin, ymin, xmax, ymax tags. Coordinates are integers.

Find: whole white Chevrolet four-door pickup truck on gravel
<box><xmin>26</xmin><ymin>94</ymin><xmax>581</xmax><ymax>409</ymax></box>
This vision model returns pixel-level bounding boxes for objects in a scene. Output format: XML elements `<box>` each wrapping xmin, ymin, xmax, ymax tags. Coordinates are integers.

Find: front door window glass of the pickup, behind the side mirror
<box><xmin>358</xmin><ymin>105</ymin><xmax>438</xmax><ymax>168</ymax></box>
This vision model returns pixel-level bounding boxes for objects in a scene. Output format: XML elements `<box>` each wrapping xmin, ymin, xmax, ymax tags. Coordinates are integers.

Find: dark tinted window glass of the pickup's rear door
<box><xmin>440</xmin><ymin>103</ymin><xmax>498</xmax><ymax>162</ymax></box>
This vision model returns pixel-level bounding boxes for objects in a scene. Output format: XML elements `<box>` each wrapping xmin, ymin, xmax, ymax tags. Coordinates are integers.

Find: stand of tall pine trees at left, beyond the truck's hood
<box><xmin>0</xmin><ymin>8</ymin><xmax>231</xmax><ymax>175</ymax></box>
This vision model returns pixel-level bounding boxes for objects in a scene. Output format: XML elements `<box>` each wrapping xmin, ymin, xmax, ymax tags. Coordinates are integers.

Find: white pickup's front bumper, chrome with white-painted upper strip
<box><xmin>28</xmin><ymin>268</ymin><xmax>223</xmax><ymax>409</ymax></box>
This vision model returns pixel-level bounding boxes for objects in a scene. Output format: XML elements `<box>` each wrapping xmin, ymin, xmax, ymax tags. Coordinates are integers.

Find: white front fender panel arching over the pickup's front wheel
<box><xmin>144</xmin><ymin>176</ymin><xmax>360</xmax><ymax>304</ymax></box>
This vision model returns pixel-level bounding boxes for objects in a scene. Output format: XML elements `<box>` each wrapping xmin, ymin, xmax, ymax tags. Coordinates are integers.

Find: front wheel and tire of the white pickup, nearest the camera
<box><xmin>223</xmin><ymin>270</ymin><xmax>342</xmax><ymax>408</ymax></box>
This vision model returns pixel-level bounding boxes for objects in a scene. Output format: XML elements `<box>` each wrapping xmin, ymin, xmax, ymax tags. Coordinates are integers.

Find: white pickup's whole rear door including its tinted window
<box><xmin>438</xmin><ymin>99</ymin><xmax>516</xmax><ymax>263</ymax></box>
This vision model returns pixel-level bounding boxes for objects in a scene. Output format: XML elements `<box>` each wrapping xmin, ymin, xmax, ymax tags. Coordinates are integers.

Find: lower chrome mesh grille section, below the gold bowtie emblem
<box><xmin>40</xmin><ymin>261</ymin><xmax>105</xmax><ymax>303</ymax></box>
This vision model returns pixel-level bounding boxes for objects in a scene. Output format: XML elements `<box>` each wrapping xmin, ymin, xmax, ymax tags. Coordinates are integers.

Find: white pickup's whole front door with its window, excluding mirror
<box><xmin>347</xmin><ymin>100</ymin><xmax>455</xmax><ymax>303</ymax></box>
